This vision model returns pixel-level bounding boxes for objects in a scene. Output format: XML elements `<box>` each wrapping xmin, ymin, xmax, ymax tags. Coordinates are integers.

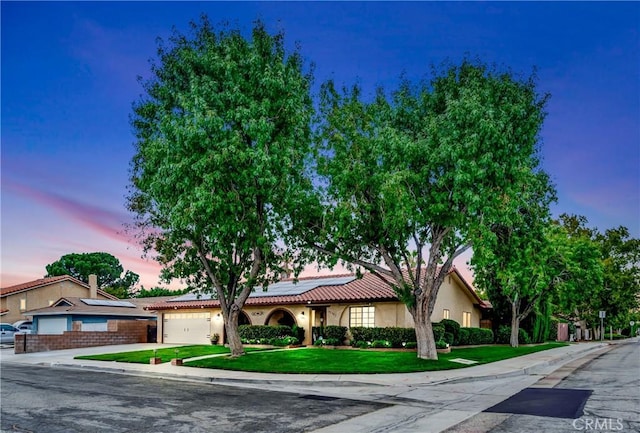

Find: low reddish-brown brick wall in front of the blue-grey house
<box><xmin>14</xmin><ymin>320</ymin><xmax>152</xmax><ymax>353</ymax></box>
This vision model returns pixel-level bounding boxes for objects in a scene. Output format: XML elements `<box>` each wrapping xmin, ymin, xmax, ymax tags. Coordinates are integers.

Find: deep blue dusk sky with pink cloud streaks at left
<box><xmin>0</xmin><ymin>2</ymin><xmax>640</xmax><ymax>288</ymax></box>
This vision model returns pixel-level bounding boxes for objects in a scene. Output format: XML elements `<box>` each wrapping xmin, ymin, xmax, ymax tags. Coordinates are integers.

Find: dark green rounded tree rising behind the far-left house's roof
<box><xmin>45</xmin><ymin>252</ymin><xmax>140</xmax><ymax>298</ymax></box>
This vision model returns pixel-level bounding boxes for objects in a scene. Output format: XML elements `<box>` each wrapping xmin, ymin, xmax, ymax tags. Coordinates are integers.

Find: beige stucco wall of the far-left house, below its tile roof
<box><xmin>1</xmin><ymin>281</ymin><xmax>108</xmax><ymax>323</ymax></box>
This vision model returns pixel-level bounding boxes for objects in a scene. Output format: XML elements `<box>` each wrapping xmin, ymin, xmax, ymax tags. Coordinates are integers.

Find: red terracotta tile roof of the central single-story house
<box><xmin>146</xmin><ymin>268</ymin><xmax>483</xmax><ymax>310</ymax></box>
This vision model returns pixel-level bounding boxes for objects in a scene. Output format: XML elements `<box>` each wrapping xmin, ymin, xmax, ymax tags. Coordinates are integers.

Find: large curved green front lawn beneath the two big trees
<box><xmin>184</xmin><ymin>343</ymin><xmax>566</xmax><ymax>374</ymax></box>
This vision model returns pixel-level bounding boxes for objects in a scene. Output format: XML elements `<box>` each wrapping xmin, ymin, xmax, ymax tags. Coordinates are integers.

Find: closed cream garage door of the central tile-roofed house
<box><xmin>162</xmin><ymin>313</ymin><xmax>211</xmax><ymax>344</ymax></box>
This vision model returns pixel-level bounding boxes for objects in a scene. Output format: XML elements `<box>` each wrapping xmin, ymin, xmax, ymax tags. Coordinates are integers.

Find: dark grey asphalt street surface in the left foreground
<box><xmin>0</xmin><ymin>365</ymin><xmax>386</xmax><ymax>433</ymax></box>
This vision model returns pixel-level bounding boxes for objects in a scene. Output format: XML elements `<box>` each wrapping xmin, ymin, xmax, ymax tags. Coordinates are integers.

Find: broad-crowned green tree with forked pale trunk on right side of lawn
<box><xmin>306</xmin><ymin>60</ymin><xmax>546</xmax><ymax>359</ymax></box>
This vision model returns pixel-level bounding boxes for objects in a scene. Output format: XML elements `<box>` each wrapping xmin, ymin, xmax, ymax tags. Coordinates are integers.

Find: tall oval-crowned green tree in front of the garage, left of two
<box><xmin>128</xmin><ymin>17</ymin><xmax>312</xmax><ymax>356</ymax></box>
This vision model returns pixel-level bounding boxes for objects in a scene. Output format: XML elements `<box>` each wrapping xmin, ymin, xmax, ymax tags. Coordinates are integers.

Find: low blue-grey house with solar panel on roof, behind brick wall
<box><xmin>26</xmin><ymin>296</ymin><xmax>156</xmax><ymax>335</ymax></box>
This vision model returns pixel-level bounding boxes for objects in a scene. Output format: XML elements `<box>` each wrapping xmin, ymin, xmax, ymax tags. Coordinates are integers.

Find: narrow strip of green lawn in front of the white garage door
<box><xmin>75</xmin><ymin>345</ymin><xmax>240</xmax><ymax>364</ymax></box>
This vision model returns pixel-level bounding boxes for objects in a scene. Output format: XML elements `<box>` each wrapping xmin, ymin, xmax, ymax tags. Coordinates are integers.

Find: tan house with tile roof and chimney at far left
<box><xmin>0</xmin><ymin>275</ymin><xmax>117</xmax><ymax>323</ymax></box>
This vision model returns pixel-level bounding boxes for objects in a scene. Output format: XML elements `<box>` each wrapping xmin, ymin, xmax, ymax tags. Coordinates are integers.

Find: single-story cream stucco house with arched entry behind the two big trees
<box><xmin>147</xmin><ymin>268</ymin><xmax>491</xmax><ymax>344</ymax></box>
